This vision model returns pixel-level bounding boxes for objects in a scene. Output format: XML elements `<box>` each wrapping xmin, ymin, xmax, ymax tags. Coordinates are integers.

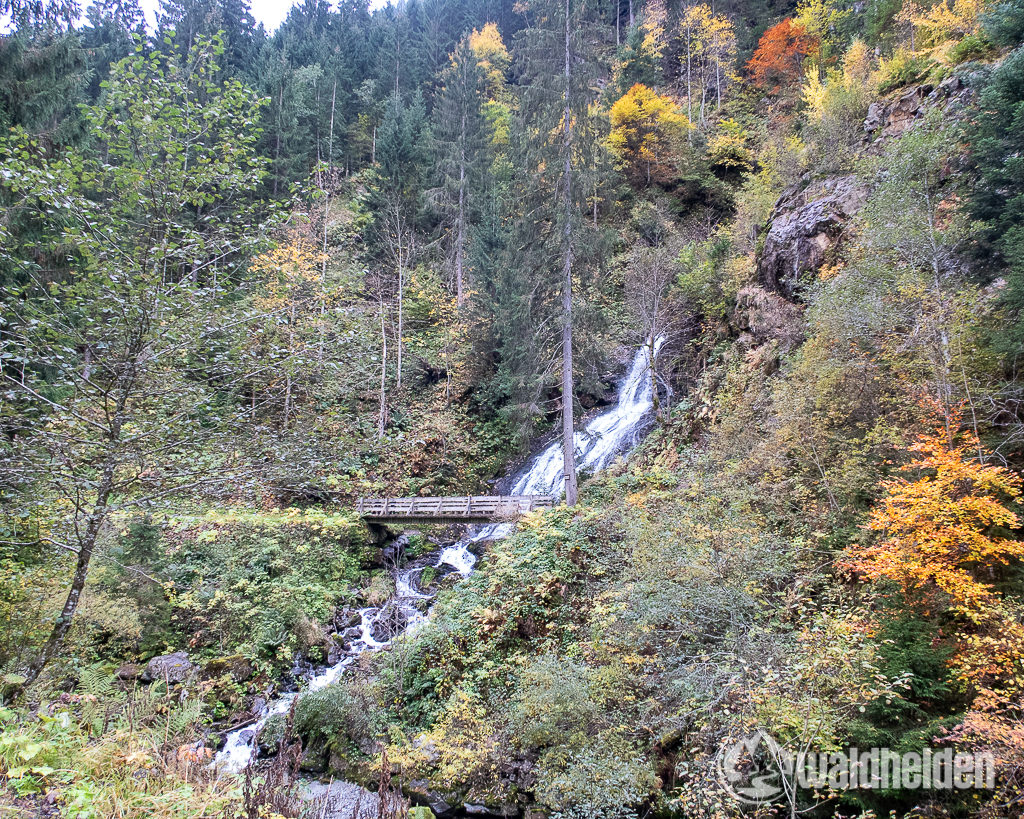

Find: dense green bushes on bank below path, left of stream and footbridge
<box><xmin>37</xmin><ymin>510</ymin><xmax>377</xmax><ymax>679</ymax></box>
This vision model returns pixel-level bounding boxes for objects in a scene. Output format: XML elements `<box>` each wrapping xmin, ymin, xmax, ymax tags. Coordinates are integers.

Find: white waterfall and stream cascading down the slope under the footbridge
<box><xmin>214</xmin><ymin>338</ymin><xmax>665</xmax><ymax>773</ymax></box>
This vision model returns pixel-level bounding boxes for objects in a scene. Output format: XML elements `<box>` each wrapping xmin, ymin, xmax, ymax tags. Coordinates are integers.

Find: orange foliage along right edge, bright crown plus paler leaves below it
<box><xmin>844</xmin><ymin>419</ymin><xmax>1024</xmax><ymax>802</ymax></box>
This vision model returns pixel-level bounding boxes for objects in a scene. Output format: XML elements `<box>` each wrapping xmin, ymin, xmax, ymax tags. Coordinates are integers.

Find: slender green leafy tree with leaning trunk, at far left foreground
<box><xmin>0</xmin><ymin>40</ymin><xmax>272</xmax><ymax>684</ymax></box>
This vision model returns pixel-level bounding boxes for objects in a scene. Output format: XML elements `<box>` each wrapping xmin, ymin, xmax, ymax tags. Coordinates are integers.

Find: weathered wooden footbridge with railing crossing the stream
<box><xmin>355</xmin><ymin>494</ymin><xmax>555</xmax><ymax>523</ymax></box>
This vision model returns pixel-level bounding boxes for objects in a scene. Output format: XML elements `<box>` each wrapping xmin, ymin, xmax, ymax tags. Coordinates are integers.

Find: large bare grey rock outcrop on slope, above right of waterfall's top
<box><xmin>758</xmin><ymin>175</ymin><xmax>868</xmax><ymax>300</ymax></box>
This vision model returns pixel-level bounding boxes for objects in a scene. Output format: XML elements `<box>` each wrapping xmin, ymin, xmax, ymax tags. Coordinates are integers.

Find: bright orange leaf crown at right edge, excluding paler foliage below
<box><xmin>845</xmin><ymin>426</ymin><xmax>1024</xmax><ymax>622</ymax></box>
